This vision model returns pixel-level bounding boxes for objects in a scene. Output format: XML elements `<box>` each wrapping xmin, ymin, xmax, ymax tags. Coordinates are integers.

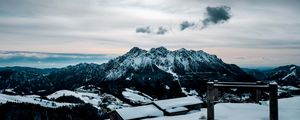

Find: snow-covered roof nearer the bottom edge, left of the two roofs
<box><xmin>116</xmin><ymin>105</ymin><xmax>164</xmax><ymax>120</ymax></box>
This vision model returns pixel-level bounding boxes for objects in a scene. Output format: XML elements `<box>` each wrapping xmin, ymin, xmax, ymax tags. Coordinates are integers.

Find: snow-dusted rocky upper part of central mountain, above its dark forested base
<box><xmin>106</xmin><ymin>47</ymin><xmax>253</xmax><ymax>81</ymax></box>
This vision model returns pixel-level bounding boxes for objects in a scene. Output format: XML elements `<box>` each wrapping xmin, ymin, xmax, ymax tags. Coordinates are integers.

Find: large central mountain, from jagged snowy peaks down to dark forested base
<box><xmin>92</xmin><ymin>47</ymin><xmax>256</xmax><ymax>99</ymax></box>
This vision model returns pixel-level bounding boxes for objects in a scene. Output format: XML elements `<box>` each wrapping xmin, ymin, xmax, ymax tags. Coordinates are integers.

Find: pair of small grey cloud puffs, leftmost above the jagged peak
<box><xmin>135</xmin><ymin>26</ymin><xmax>169</xmax><ymax>35</ymax></box>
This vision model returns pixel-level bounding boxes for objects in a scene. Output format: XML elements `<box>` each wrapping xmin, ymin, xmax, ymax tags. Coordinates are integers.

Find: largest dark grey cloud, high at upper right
<box><xmin>202</xmin><ymin>6</ymin><xmax>231</xmax><ymax>29</ymax></box>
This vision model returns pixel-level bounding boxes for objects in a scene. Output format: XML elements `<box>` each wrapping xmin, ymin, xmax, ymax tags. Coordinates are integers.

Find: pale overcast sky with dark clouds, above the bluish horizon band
<box><xmin>0</xmin><ymin>0</ymin><xmax>300</xmax><ymax>67</ymax></box>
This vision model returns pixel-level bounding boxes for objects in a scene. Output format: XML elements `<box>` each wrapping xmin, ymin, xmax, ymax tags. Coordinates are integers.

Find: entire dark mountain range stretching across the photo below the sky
<box><xmin>0</xmin><ymin>47</ymin><xmax>299</xmax><ymax>98</ymax></box>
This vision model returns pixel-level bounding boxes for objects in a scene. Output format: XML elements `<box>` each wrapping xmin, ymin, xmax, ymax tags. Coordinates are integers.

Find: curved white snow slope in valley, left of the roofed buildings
<box><xmin>47</xmin><ymin>90</ymin><xmax>102</xmax><ymax>109</ymax></box>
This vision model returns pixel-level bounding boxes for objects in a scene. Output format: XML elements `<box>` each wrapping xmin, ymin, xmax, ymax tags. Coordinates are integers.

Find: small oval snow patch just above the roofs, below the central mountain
<box><xmin>122</xmin><ymin>88</ymin><xmax>153</xmax><ymax>104</ymax></box>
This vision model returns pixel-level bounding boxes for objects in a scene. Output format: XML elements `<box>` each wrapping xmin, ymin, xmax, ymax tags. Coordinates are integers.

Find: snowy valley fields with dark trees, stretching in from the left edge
<box><xmin>0</xmin><ymin>90</ymin><xmax>130</xmax><ymax>110</ymax></box>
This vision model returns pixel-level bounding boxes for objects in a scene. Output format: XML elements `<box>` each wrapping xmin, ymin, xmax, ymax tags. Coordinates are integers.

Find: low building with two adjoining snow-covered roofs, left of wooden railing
<box><xmin>110</xmin><ymin>96</ymin><xmax>203</xmax><ymax>120</ymax></box>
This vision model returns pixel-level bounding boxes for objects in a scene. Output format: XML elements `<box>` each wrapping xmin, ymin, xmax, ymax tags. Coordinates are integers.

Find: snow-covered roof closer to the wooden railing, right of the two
<box><xmin>153</xmin><ymin>96</ymin><xmax>203</xmax><ymax>110</ymax></box>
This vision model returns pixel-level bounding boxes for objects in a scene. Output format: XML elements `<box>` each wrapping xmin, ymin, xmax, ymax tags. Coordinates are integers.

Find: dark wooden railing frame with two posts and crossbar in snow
<box><xmin>207</xmin><ymin>80</ymin><xmax>278</xmax><ymax>120</ymax></box>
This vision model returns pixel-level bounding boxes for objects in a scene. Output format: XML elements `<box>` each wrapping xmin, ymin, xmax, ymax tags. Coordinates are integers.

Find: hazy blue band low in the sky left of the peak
<box><xmin>0</xmin><ymin>50</ymin><xmax>115</xmax><ymax>68</ymax></box>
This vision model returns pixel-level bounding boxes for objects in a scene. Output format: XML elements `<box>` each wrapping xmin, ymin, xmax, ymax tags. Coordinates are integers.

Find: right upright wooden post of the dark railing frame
<box><xmin>269</xmin><ymin>83</ymin><xmax>278</xmax><ymax>120</ymax></box>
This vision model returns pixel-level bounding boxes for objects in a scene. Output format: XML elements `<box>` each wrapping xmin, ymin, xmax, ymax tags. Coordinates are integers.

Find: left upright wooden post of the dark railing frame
<box><xmin>207</xmin><ymin>82</ymin><xmax>214</xmax><ymax>120</ymax></box>
